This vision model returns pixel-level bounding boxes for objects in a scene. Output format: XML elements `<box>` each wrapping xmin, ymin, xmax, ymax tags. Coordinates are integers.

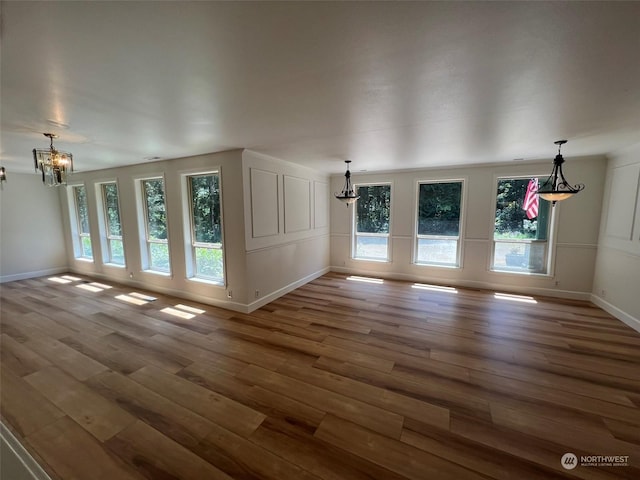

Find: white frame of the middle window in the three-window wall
<box><xmin>413</xmin><ymin>177</ymin><xmax>467</xmax><ymax>269</ymax></box>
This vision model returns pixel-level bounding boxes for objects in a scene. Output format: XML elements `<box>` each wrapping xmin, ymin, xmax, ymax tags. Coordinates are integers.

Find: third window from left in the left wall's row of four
<box><xmin>141</xmin><ymin>178</ymin><xmax>171</xmax><ymax>273</ymax></box>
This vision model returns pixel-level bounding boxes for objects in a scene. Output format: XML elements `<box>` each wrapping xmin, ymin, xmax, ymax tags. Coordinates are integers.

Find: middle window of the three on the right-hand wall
<box><xmin>416</xmin><ymin>181</ymin><xmax>462</xmax><ymax>267</ymax></box>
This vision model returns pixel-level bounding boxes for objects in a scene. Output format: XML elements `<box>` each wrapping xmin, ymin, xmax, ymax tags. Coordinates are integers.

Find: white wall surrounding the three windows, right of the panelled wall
<box><xmin>331</xmin><ymin>156</ymin><xmax>606</xmax><ymax>299</ymax></box>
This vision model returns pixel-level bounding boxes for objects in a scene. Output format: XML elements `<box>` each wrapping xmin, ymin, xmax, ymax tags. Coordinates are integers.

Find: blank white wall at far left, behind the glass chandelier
<box><xmin>0</xmin><ymin>172</ymin><xmax>67</xmax><ymax>282</ymax></box>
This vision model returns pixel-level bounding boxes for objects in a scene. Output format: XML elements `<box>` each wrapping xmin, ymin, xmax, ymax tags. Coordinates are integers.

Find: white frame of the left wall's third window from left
<box><xmin>136</xmin><ymin>174</ymin><xmax>173</xmax><ymax>276</ymax></box>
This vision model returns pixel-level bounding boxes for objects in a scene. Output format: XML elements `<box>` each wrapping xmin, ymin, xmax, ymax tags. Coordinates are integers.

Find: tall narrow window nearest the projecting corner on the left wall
<box><xmin>187</xmin><ymin>173</ymin><xmax>224</xmax><ymax>283</ymax></box>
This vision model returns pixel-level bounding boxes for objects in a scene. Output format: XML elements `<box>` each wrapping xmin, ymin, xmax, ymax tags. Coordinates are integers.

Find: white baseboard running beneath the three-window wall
<box><xmin>331</xmin><ymin>267</ymin><xmax>591</xmax><ymax>301</ymax></box>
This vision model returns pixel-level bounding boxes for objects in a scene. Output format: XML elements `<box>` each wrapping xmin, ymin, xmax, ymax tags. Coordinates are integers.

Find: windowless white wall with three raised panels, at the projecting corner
<box><xmin>242</xmin><ymin>150</ymin><xmax>330</xmax><ymax>309</ymax></box>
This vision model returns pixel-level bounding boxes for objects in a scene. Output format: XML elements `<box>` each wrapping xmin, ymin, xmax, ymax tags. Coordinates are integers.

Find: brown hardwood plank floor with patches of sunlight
<box><xmin>0</xmin><ymin>274</ymin><xmax>640</xmax><ymax>480</ymax></box>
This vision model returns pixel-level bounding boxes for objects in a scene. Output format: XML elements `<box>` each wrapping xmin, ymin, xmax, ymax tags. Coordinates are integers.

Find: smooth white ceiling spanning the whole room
<box><xmin>0</xmin><ymin>1</ymin><xmax>640</xmax><ymax>173</ymax></box>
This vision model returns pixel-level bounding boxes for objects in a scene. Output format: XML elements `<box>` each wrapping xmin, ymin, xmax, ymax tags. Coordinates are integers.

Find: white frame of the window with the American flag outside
<box><xmin>488</xmin><ymin>173</ymin><xmax>559</xmax><ymax>277</ymax></box>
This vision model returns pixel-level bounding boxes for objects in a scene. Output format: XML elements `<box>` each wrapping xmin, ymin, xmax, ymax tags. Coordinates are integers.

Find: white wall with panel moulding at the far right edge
<box><xmin>592</xmin><ymin>144</ymin><xmax>640</xmax><ymax>331</ymax></box>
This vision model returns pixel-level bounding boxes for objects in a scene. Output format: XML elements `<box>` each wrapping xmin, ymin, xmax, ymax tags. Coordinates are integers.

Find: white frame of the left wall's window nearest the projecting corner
<box><xmin>182</xmin><ymin>168</ymin><xmax>227</xmax><ymax>287</ymax></box>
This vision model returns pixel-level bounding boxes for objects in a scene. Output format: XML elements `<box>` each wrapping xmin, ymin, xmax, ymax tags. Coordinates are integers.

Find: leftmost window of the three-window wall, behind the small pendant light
<box><xmin>353</xmin><ymin>185</ymin><xmax>391</xmax><ymax>261</ymax></box>
